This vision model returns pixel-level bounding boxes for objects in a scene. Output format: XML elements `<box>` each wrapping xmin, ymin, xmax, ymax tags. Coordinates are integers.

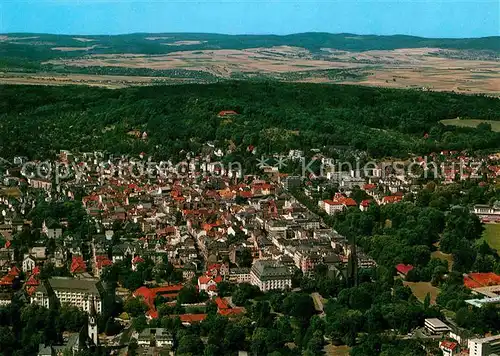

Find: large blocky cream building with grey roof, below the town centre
<box><xmin>250</xmin><ymin>260</ymin><xmax>292</xmax><ymax>292</ymax></box>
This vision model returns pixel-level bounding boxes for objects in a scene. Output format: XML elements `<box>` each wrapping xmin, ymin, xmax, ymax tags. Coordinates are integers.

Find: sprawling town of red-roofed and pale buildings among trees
<box><xmin>0</xmin><ymin>140</ymin><xmax>500</xmax><ymax>356</ymax></box>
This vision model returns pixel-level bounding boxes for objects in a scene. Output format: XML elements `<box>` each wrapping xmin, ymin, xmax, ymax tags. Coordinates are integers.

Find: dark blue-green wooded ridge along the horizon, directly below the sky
<box><xmin>0</xmin><ymin>32</ymin><xmax>500</xmax><ymax>60</ymax></box>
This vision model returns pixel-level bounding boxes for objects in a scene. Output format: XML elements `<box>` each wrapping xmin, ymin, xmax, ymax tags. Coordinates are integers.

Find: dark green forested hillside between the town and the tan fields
<box><xmin>0</xmin><ymin>82</ymin><xmax>500</xmax><ymax>159</ymax></box>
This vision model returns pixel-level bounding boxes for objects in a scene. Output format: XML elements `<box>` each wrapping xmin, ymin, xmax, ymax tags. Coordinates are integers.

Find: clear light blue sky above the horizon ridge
<box><xmin>0</xmin><ymin>0</ymin><xmax>500</xmax><ymax>37</ymax></box>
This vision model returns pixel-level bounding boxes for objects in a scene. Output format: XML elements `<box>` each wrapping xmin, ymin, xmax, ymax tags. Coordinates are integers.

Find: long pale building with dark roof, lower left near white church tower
<box><xmin>31</xmin><ymin>277</ymin><xmax>104</xmax><ymax>313</ymax></box>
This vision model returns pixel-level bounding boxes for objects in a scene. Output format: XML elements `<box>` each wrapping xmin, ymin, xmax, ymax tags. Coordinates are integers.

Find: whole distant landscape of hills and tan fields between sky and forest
<box><xmin>0</xmin><ymin>32</ymin><xmax>500</xmax><ymax>95</ymax></box>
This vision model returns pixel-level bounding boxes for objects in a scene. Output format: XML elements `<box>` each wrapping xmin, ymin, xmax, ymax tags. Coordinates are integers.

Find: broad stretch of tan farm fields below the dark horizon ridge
<box><xmin>39</xmin><ymin>46</ymin><xmax>500</xmax><ymax>95</ymax></box>
